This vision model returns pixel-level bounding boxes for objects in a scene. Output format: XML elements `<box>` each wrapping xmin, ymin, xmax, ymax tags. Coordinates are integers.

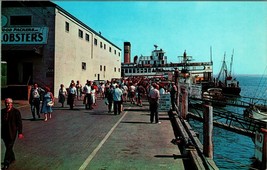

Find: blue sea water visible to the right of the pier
<box><xmin>189</xmin><ymin>75</ymin><xmax>267</xmax><ymax>170</ymax></box>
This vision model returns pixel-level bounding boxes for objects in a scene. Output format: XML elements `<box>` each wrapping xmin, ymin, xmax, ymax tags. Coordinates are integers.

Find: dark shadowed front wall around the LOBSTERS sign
<box><xmin>2</xmin><ymin>7</ymin><xmax>55</xmax><ymax>88</ymax></box>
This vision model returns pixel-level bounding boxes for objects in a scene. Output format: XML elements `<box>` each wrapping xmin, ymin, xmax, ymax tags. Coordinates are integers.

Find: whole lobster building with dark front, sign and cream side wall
<box><xmin>1</xmin><ymin>1</ymin><xmax>121</xmax><ymax>96</ymax></box>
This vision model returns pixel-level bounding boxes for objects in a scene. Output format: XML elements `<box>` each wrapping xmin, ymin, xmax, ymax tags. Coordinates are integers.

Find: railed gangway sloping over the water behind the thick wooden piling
<box><xmin>187</xmin><ymin>100</ymin><xmax>267</xmax><ymax>140</ymax></box>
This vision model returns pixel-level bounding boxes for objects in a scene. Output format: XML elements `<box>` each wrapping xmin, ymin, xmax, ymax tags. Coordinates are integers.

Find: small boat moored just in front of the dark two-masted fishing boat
<box><xmin>202</xmin><ymin>88</ymin><xmax>226</xmax><ymax>107</ymax></box>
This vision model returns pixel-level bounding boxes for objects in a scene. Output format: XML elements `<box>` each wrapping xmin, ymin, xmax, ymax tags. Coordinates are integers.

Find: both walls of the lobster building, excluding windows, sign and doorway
<box><xmin>2</xmin><ymin>2</ymin><xmax>121</xmax><ymax>97</ymax></box>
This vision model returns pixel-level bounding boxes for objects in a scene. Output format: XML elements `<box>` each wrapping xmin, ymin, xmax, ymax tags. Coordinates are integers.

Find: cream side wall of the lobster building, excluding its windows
<box><xmin>55</xmin><ymin>9</ymin><xmax>121</xmax><ymax>95</ymax></box>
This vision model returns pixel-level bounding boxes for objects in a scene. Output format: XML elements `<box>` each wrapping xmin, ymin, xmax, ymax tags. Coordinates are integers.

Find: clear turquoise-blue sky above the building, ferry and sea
<box><xmin>53</xmin><ymin>1</ymin><xmax>267</xmax><ymax>75</ymax></box>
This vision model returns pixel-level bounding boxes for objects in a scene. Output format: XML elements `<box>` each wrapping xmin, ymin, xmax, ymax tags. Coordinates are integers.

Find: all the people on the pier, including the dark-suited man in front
<box><xmin>1</xmin><ymin>77</ymin><xmax>177</xmax><ymax>169</ymax></box>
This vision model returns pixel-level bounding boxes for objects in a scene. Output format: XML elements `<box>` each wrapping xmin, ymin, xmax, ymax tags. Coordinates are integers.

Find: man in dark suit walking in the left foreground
<box><xmin>1</xmin><ymin>98</ymin><xmax>23</xmax><ymax>169</ymax></box>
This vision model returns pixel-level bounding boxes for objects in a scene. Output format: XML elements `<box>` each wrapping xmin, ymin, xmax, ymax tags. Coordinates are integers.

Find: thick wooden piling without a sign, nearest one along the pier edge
<box><xmin>203</xmin><ymin>105</ymin><xmax>213</xmax><ymax>159</ymax></box>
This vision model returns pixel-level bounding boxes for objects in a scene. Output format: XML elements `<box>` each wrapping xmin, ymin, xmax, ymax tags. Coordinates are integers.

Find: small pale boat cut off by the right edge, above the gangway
<box><xmin>244</xmin><ymin>104</ymin><xmax>267</xmax><ymax>122</ymax></box>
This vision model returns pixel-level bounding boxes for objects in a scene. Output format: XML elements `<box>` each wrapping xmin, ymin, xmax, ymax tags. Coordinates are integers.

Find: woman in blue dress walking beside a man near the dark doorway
<box><xmin>41</xmin><ymin>87</ymin><xmax>55</xmax><ymax>122</ymax></box>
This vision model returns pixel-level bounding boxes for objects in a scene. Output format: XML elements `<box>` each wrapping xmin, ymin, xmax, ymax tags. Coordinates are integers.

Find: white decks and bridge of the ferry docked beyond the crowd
<box><xmin>121</xmin><ymin>45</ymin><xmax>213</xmax><ymax>83</ymax></box>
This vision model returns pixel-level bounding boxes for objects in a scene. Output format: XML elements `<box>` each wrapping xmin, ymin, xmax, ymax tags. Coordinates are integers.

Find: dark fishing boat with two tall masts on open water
<box><xmin>215</xmin><ymin>50</ymin><xmax>241</xmax><ymax>96</ymax></box>
